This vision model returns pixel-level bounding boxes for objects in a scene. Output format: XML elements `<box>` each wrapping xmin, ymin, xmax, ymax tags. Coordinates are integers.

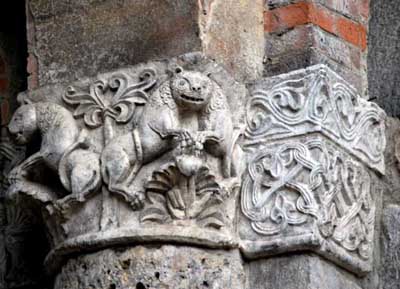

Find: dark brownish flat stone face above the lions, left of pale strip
<box><xmin>28</xmin><ymin>0</ymin><xmax>201</xmax><ymax>85</ymax></box>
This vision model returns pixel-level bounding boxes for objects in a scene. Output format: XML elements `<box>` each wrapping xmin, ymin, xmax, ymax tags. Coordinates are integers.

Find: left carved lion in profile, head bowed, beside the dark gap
<box><xmin>8</xmin><ymin>102</ymin><xmax>101</xmax><ymax>200</ymax></box>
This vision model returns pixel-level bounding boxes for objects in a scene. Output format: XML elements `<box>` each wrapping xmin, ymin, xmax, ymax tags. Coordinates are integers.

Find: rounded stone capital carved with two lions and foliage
<box><xmin>8</xmin><ymin>54</ymin><xmax>245</xmax><ymax>271</ymax></box>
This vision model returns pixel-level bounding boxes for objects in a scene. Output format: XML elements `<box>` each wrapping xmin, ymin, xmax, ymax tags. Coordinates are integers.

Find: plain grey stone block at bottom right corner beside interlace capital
<box><xmin>379</xmin><ymin>205</ymin><xmax>400</xmax><ymax>289</ymax></box>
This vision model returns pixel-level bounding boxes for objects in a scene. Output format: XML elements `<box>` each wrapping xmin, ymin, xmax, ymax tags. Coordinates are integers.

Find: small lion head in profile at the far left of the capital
<box><xmin>8</xmin><ymin>104</ymin><xmax>37</xmax><ymax>144</ymax></box>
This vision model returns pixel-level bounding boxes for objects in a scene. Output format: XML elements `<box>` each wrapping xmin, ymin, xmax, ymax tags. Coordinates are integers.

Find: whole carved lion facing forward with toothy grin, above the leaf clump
<box><xmin>101</xmin><ymin>67</ymin><xmax>242</xmax><ymax>202</ymax></box>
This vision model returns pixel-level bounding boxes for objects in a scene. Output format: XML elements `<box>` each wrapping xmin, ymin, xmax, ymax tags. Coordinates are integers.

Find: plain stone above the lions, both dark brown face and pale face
<box><xmin>28</xmin><ymin>0</ymin><xmax>264</xmax><ymax>86</ymax></box>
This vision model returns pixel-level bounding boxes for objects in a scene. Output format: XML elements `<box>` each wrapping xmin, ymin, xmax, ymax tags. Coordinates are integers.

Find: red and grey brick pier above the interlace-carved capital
<box><xmin>264</xmin><ymin>0</ymin><xmax>372</xmax><ymax>97</ymax></box>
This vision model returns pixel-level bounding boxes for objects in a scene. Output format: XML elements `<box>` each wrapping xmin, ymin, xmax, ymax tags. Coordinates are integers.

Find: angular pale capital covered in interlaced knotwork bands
<box><xmin>239</xmin><ymin>65</ymin><xmax>385</xmax><ymax>274</ymax></box>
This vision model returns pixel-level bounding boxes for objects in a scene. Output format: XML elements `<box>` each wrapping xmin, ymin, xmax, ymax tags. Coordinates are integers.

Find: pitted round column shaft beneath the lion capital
<box><xmin>54</xmin><ymin>246</ymin><xmax>245</xmax><ymax>289</ymax></box>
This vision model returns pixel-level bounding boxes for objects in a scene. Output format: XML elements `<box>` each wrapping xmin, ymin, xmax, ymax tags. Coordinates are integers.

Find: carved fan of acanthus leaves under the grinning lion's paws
<box><xmin>141</xmin><ymin>156</ymin><xmax>227</xmax><ymax>228</ymax></box>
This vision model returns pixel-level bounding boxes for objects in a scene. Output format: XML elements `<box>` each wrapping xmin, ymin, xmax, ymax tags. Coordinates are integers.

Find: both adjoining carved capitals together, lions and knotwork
<box><xmin>8</xmin><ymin>54</ymin><xmax>385</xmax><ymax>274</ymax></box>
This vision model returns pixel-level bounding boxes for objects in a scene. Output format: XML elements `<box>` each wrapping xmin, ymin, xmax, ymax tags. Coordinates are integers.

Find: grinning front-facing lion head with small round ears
<box><xmin>170</xmin><ymin>67</ymin><xmax>215</xmax><ymax>111</ymax></box>
